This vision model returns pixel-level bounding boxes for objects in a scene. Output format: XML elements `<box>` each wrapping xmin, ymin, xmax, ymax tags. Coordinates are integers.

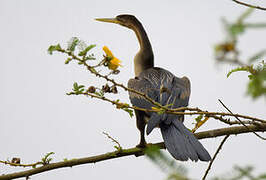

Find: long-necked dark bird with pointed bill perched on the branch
<box><xmin>95</xmin><ymin>14</ymin><xmax>211</xmax><ymax>162</ymax></box>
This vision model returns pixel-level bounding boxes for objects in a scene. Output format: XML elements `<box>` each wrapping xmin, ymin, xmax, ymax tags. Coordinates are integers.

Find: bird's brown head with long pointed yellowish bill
<box><xmin>95</xmin><ymin>14</ymin><xmax>139</xmax><ymax>29</ymax></box>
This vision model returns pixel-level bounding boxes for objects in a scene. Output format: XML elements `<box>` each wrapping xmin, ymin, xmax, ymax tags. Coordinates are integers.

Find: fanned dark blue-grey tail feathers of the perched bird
<box><xmin>160</xmin><ymin>116</ymin><xmax>211</xmax><ymax>161</ymax></box>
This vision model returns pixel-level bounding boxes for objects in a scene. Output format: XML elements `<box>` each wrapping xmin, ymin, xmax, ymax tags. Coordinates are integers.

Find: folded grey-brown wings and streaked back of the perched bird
<box><xmin>128</xmin><ymin>68</ymin><xmax>190</xmax><ymax>133</ymax></box>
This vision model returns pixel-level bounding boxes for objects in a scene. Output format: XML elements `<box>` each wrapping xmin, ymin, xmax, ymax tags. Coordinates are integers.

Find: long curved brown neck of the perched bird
<box><xmin>132</xmin><ymin>21</ymin><xmax>154</xmax><ymax>76</ymax></box>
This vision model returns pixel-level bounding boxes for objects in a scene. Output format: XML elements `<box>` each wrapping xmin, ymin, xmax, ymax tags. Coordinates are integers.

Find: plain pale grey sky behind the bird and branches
<box><xmin>0</xmin><ymin>0</ymin><xmax>266</xmax><ymax>180</ymax></box>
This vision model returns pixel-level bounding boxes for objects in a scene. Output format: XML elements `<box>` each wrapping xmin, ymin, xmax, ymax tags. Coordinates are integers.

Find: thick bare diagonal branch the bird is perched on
<box><xmin>0</xmin><ymin>123</ymin><xmax>266</xmax><ymax>180</ymax></box>
